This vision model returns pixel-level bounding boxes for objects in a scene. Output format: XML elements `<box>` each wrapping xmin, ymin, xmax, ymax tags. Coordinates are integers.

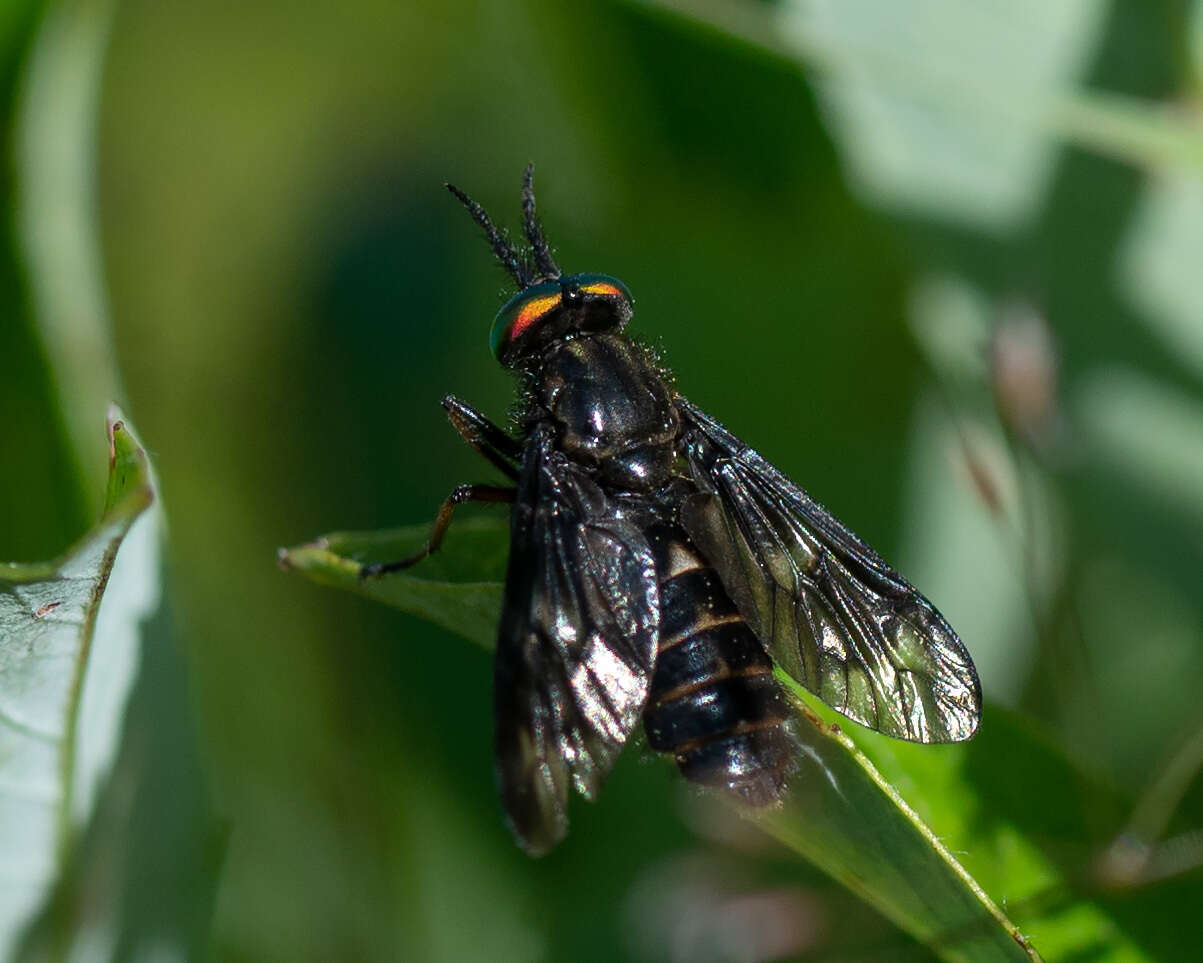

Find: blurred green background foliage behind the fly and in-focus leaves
<box><xmin>7</xmin><ymin>0</ymin><xmax>1203</xmax><ymax>961</ymax></box>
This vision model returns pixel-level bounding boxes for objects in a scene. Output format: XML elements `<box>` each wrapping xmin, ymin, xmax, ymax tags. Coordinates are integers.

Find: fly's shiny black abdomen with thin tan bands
<box><xmin>644</xmin><ymin>525</ymin><xmax>795</xmax><ymax>805</ymax></box>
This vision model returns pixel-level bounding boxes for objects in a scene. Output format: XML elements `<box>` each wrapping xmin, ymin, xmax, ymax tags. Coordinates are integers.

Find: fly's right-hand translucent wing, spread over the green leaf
<box><xmin>677</xmin><ymin>397</ymin><xmax>982</xmax><ymax>743</ymax></box>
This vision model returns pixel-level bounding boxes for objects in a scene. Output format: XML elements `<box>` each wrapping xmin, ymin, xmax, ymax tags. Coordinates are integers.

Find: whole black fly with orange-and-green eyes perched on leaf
<box><xmin>362</xmin><ymin>167</ymin><xmax>982</xmax><ymax>853</ymax></box>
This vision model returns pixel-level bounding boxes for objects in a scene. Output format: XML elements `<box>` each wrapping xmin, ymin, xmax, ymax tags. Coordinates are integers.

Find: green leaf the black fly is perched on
<box><xmin>280</xmin><ymin>519</ymin><xmax>1145</xmax><ymax>961</ymax></box>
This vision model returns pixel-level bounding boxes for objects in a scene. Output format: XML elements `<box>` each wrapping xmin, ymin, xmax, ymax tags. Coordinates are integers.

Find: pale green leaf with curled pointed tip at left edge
<box><xmin>0</xmin><ymin>408</ymin><xmax>159</xmax><ymax>958</ymax></box>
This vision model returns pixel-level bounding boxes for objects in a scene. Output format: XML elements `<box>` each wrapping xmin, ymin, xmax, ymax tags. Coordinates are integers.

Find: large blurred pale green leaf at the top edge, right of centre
<box><xmin>781</xmin><ymin>0</ymin><xmax>1104</xmax><ymax>232</ymax></box>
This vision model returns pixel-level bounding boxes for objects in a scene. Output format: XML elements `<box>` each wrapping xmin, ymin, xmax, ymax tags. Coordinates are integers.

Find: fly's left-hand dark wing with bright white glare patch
<box><xmin>493</xmin><ymin>429</ymin><xmax>659</xmax><ymax>853</ymax></box>
